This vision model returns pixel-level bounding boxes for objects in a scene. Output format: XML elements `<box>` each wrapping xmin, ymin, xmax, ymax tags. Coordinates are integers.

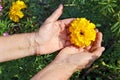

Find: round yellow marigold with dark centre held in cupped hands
<box><xmin>69</xmin><ymin>18</ymin><xmax>96</xmax><ymax>47</ymax></box>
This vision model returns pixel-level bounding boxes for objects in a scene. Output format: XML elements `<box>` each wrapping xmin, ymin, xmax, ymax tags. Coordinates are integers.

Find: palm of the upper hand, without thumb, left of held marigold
<box><xmin>35</xmin><ymin>21</ymin><xmax>67</xmax><ymax>54</ymax></box>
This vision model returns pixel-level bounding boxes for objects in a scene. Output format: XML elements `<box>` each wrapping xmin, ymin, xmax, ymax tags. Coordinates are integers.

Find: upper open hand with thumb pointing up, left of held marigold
<box><xmin>35</xmin><ymin>5</ymin><xmax>74</xmax><ymax>54</ymax></box>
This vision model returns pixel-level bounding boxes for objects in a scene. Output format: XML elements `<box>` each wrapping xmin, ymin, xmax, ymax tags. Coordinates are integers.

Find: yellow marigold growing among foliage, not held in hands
<box><xmin>9</xmin><ymin>0</ymin><xmax>26</xmax><ymax>22</ymax></box>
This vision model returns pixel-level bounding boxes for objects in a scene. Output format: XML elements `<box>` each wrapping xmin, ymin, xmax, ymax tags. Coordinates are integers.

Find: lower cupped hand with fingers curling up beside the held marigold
<box><xmin>54</xmin><ymin>32</ymin><xmax>104</xmax><ymax>69</ymax></box>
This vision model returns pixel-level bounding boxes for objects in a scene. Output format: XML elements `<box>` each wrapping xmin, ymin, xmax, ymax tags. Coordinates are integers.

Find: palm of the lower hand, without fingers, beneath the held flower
<box><xmin>57</xmin><ymin>46</ymin><xmax>98</xmax><ymax>69</ymax></box>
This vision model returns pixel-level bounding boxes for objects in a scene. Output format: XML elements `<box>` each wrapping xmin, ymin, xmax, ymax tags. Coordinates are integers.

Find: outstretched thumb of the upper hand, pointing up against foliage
<box><xmin>45</xmin><ymin>4</ymin><xmax>63</xmax><ymax>23</ymax></box>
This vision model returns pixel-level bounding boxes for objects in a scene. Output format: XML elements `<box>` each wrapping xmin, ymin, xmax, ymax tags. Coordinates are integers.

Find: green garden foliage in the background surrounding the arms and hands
<box><xmin>0</xmin><ymin>0</ymin><xmax>120</xmax><ymax>80</ymax></box>
